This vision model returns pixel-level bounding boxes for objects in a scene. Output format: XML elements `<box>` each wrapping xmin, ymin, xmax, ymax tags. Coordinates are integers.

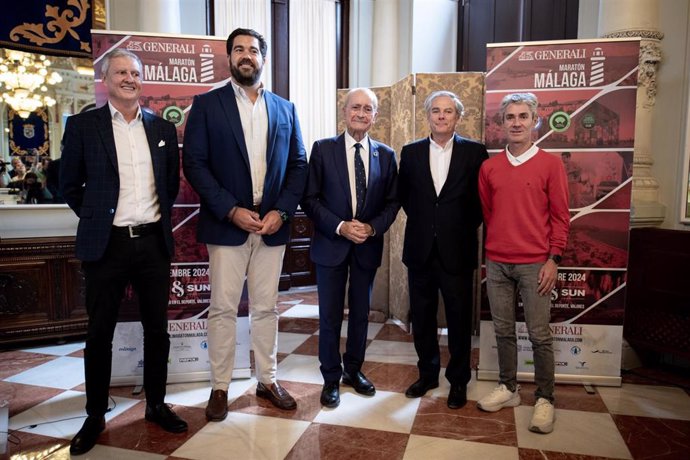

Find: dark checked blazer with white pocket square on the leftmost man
<box><xmin>60</xmin><ymin>104</ymin><xmax>180</xmax><ymax>261</ymax></box>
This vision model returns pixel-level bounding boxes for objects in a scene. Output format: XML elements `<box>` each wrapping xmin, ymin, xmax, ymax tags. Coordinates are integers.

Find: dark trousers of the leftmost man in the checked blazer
<box><xmin>82</xmin><ymin>230</ymin><xmax>170</xmax><ymax>416</ymax></box>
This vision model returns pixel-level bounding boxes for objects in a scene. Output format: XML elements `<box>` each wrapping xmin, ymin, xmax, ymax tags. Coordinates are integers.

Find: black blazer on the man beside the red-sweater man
<box><xmin>398</xmin><ymin>134</ymin><xmax>488</xmax><ymax>274</ymax></box>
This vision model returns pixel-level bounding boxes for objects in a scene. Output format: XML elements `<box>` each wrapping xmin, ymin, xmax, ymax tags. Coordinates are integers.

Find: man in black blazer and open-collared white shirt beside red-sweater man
<box><xmin>398</xmin><ymin>91</ymin><xmax>488</xmax><ymax>409</ymax></box>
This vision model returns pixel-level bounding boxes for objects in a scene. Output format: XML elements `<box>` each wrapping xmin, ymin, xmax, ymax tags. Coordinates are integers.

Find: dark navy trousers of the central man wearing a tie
<box><xmin>316</xmin><ymin>251</ymin><xmax>376</xmax><ymax>382</ymax></box>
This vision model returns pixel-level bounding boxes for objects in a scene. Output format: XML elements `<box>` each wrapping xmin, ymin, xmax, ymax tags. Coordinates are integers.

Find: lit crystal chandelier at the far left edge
<box><xmin>0</xmin><ymin>50</ymin><xmax>62</xmax><ymax>118</ymax></box>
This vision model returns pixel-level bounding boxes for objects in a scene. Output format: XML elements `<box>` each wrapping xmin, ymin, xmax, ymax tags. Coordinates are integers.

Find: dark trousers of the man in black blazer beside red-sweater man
<box><xmin>407</xmin><ymin>244</ymin><xmax>473</xmax><ymax>385</ymax></box>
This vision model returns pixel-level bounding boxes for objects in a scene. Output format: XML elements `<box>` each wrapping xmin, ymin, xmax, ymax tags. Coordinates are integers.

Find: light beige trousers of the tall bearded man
<box><xmin>207</xmin><ymin>234</ymin><xmax>285</xmax><ymax>391</ymax></box>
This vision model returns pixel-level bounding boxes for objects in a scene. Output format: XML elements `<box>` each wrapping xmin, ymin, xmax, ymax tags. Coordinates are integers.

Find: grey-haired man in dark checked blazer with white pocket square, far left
<box><xmin>60</xmin><ymin>49</ymin><xmax>187</xmax><ymax>454</ymax></box>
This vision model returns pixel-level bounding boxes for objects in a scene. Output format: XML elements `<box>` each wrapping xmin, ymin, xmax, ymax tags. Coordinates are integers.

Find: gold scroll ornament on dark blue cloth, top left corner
<box><xmin>10</xmin><ymin>0</ymin><xmax>91</xmax><ymax>52</ymax></box>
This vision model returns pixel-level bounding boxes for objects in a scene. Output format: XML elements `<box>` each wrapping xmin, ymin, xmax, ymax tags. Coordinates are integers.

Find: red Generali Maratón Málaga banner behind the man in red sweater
<box><xmin>478</xmin><ymin>39</ymin><xmax>640</xmax><ymax>386</ymax></box>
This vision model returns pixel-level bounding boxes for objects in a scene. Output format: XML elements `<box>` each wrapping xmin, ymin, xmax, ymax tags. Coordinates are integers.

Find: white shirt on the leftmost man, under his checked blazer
<box><xmin>108</xmin><ymin>102</ymin><xmax>161</xmax><ymax>227</ymax></box>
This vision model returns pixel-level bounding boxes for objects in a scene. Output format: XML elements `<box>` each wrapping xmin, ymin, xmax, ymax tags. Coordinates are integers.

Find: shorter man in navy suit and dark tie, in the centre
<box><xmin>302</xmin><ymin>88</ymin><xmax>400</xmax><ymax>407</ymax></box>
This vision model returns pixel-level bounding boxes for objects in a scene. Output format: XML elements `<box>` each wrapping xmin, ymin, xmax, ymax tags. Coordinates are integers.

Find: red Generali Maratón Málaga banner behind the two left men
<box><xmin>92</xmin><ymin>30</ymin><xmax>250</xmax><ymax>385</ymax></box>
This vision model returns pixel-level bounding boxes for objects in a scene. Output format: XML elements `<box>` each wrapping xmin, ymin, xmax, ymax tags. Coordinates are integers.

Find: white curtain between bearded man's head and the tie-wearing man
<box><xmin>288</xmin><ymin>0</ymin><xmax>337</xmax><ymax>154</ymax></box>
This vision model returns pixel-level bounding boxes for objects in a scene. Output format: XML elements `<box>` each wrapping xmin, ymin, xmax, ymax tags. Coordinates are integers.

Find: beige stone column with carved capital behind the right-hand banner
<box><xmin>598</xmin><ymin>0</ymin><xmax>666</xmax><ymax>227</ymax></box>
